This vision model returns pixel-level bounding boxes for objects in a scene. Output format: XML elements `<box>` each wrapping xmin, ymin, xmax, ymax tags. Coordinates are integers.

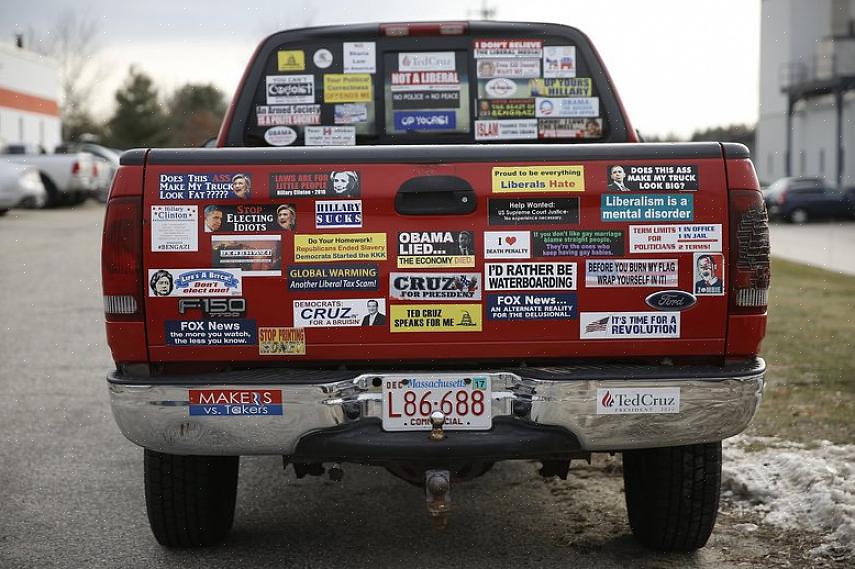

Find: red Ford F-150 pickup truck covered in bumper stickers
<box><xmin>102</xmin><ymin>22</ymin><xmax>769</xmax><ymax>551</ymax></box>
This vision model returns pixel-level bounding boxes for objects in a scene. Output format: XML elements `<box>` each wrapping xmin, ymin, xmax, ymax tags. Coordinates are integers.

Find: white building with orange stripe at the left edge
<box><xmin>0</xmin><ymin>40</ymin><xmax>62</xmax><ymax>150</ymax></box>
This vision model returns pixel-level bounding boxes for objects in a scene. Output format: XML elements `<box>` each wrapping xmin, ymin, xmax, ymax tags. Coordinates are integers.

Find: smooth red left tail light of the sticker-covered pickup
<box><xmin>101</xmin><ymin>197</ymin><xmax>144</xmax><ymax>322</ymax></box>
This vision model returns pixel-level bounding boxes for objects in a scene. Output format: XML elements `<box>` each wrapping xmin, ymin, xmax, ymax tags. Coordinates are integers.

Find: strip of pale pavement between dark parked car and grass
<box><xmin>769</xmin><ymin>221</ymin><xmax>855</xmax><ymax>275</ymax></box>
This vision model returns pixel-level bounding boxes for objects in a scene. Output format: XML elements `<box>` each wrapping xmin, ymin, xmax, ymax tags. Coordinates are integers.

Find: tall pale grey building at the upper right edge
<box><xmin>754</xmin><ymin>0</ymin><xmax>855</xmax><ymax>186</ymax></box>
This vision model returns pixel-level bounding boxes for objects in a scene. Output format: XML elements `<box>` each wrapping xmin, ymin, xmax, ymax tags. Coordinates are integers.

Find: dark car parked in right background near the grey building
<box><xmin>763</xmin><ymin>177</ymin><xmax>852</xmax><ymax>223</ymax></box>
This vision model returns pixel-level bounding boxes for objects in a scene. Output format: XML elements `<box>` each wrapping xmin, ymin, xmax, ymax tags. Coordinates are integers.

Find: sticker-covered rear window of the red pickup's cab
<box><xmin>234</xmin><ymin>26</ymin><xmax>625</xmax><ymax>146</ymax></box>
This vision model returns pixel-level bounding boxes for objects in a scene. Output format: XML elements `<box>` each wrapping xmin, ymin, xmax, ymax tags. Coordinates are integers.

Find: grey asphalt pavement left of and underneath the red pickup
<box><xmin>0</xmin><ymin>203</ymin><xmax>828</xmax><ymax>569</ymax></box>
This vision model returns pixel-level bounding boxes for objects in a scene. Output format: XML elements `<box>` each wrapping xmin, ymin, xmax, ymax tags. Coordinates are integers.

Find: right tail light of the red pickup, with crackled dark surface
<box><xmin>729</xmin><ymin>190</ymin><xmax>770</xmax><ymax>314</ymax></box>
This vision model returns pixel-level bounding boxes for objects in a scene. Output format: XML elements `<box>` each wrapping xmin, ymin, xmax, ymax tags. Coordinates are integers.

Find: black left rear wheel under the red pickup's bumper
<box><xmin>145</xmin><ymin>449</ymin><xmax>239</xmax><ymax>547</ymax></box>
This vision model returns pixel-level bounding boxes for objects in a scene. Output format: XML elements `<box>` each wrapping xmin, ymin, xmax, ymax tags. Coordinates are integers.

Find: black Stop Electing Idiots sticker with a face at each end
<box><xmin>204</xmin><ymin>204</ymin><xmax>297</xmax><ymax>233</ymax></box>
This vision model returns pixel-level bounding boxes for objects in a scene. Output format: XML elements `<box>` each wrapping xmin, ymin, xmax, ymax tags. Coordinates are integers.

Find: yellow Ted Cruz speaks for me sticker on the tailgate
<box><xmin>391</xmin><ymin>304</ymin><xmax>481</xmax><ymax>332</ymax></box>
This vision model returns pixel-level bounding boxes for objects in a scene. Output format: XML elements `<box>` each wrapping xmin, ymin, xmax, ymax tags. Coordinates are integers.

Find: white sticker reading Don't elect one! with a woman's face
<box><xmin>148</xmin><ymin>269</ymin><xmax>243</xmax><ymax>296</ymax></box>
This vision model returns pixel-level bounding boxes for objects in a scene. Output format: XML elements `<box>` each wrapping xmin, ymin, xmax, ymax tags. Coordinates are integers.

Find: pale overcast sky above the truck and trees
<box><xmin>0</xmin><ymin>0</ymin><xmax>760</xmax><ymax>136</ymax></box>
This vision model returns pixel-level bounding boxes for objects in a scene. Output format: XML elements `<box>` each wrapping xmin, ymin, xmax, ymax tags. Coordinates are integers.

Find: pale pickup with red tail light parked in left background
<box><xmin>0</xmin><ymin>144</ymin><xmax>98</xmax><ymax>207</ymax></box>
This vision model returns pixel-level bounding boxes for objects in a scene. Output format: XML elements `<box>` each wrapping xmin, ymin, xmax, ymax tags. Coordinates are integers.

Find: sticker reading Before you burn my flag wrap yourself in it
<box><xmin>585</xmin><ymin>259</ymin><xmax>679</xmax><ymax>288</ymax></box>
